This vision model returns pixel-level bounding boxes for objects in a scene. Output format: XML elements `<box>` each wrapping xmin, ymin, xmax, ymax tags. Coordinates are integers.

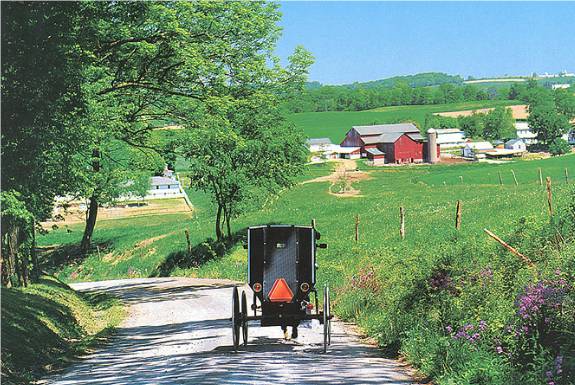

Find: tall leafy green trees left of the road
<box><xmin>2</xmin><ymin>2</ymin><xmax>312</xmax><ymax>285</ymax></box>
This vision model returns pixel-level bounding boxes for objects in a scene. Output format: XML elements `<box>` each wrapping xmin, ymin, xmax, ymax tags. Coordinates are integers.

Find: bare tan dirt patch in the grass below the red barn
<box><xmin>303</xmin><ymin>159</ymin><xmax>372</xmax><ymax>198</ymax></box>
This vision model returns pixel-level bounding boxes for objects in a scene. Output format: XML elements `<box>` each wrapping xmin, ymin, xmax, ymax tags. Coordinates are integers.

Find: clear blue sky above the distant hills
<box><xmin>276</xmin><ymin>2</ymin><xmax>575</xmax><ymax>84</ymax></box>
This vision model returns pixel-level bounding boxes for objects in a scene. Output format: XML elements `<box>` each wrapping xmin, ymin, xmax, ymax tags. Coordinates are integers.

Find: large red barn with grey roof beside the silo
<box><xmin>341</xmin><ymin>123</ymin><xmax>439</xmax><ymax>164</ymax></box>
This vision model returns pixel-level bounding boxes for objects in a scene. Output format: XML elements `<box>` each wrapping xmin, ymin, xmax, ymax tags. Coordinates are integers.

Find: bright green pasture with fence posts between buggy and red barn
<box><xmin>39</xmin><ymin>155</ymin><xmax>575</xmax><ymax>282</ymax></box>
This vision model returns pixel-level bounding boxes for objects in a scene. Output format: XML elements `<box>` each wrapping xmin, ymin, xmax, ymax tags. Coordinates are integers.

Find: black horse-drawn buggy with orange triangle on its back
<box><xmin>232</xmin><ymin>225</ymin><xmax>333</xmax><ymax>352</ymax></box>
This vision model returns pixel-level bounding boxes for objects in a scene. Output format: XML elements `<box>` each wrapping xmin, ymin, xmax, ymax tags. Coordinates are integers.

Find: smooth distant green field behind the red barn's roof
<box><xmin>288</xmin><ymin>100</ymin><xmax>519</xmax><ymax>143</ymax></box>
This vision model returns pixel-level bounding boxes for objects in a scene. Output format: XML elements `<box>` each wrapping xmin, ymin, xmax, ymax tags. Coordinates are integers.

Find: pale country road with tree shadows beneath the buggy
<box><xmin>41</xmin><ymin>278</ymin><xmax>413</xmax><ymax>385</ymax></box>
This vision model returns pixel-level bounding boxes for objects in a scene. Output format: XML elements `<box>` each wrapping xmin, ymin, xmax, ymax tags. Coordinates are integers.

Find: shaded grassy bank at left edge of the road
<box><xmin>2</xmin><ymin>277</ymin><xmax>124</xmax><ymax>384</ymax></box>
